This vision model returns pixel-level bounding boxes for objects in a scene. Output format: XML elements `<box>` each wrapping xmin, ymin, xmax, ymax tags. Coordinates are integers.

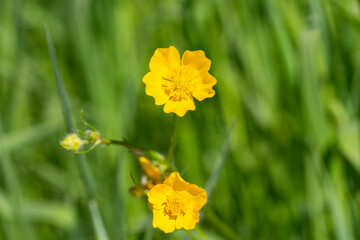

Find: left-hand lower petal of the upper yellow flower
<box><xmin>143</xmin><ymin>72</ymin><xmax>169</xmax><ymax>105</ymax></box>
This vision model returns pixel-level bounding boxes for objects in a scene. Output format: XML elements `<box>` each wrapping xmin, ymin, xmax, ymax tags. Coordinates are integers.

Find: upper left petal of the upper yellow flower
<box><xmin>150</xmin><ymin>46</ymin><xmax>180</xmax><ymax>77</ymax></box>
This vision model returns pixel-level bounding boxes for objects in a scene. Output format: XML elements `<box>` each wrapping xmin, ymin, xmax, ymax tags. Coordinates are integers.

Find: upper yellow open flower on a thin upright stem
<box><xmin>143</xmin><ymin>46</ymin><xmax>216</xmax><ymax>117</ymax></box>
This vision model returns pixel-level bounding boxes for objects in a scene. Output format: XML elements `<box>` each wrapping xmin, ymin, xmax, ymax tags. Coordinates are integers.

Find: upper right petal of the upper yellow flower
<box><xmin>181</xmin><ymin>50</ymin><xmax>211</xmax><ymax>80</ymax></box>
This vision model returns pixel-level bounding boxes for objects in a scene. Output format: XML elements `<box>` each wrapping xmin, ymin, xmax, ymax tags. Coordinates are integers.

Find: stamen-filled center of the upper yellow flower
<box><xmin>161</xmin><ymin>72</ymin><xmax>196</xmax><ymax>102</ymax></box>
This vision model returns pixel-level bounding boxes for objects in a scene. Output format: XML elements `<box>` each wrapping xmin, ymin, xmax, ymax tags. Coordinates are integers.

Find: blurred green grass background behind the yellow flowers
<box><xmin>0</xmin><ymin>0</ymin><xmax>360</xmax><ymax>240</ymax></box>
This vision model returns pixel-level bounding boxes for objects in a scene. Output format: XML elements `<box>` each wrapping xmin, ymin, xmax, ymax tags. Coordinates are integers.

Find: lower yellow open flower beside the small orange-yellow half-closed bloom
<box><xmin>147</xmin><ymin>172</ymin><xmax>207</xmax><ymax>233</ymax></box>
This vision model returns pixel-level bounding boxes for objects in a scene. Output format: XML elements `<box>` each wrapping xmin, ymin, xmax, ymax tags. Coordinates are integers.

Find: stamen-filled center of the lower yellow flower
<box><xmin>163</xmin><ymin>191</ymin><xmax>191</xmax><ymax>219</ymax></box>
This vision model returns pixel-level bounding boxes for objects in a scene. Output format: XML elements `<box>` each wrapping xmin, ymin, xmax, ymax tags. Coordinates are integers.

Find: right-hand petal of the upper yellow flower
<box><xmin>192</xmin><ymin>73</ymin><xmax>216</xmax><ymax>101</ymax></box>
